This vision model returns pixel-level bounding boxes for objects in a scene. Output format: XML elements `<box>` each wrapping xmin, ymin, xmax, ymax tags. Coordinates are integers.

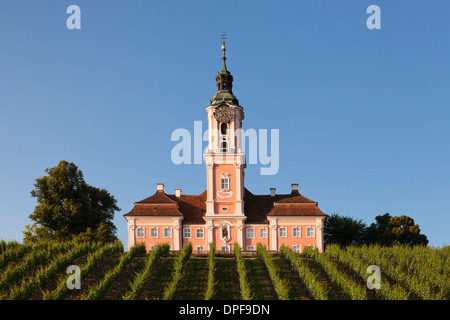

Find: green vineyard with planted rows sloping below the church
<box><xmin>0</xmin><ymin>241</ymin><xmax>450</xmax><ymax>300</ymax></box>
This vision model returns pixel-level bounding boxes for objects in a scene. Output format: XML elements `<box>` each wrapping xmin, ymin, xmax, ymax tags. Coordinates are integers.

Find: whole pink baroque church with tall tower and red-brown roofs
<box><xmin>124</xmin><ymin>36</ymin><xmax>326</xmax><ymax>254</ymax></box>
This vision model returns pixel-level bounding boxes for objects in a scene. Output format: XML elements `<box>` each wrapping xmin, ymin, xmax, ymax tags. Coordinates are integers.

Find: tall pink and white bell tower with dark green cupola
<box><xmin>204</xmin><ymin>33</ymin><xmax>246</xmax><ymax>248</ymax></box>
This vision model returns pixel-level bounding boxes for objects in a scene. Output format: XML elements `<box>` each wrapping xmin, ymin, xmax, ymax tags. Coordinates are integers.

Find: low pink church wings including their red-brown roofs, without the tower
<box><xmin>125</xmin><ymin>184</ymin><xmax>326</xmax><ymax>253</ymax></box>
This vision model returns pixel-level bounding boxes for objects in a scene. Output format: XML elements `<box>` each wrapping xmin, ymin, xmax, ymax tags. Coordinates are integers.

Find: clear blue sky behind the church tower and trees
<box><xmin>0</xmin><ymin>0</ymin><xmax>450</xmax><ymax>246</ymax></box>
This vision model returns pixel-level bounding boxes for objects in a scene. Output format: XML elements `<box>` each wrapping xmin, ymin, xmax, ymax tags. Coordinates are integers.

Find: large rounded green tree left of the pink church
<box><xmin>23</xmin><ymin>160</ymin><xmax>120</xmax><ymax>242</ymax></box>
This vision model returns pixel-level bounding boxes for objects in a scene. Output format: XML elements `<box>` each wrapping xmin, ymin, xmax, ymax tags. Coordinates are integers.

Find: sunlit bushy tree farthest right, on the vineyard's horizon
<box><xmin>363</xmin><ymin>213</ymin><xmax>428</xmax><ymax>246</ymax></box>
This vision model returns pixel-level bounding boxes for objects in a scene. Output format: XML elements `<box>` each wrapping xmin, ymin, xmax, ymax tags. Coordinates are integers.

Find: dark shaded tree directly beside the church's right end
<box><xmin>324</xmin><ymin>213</ymin><xmax>366</xmax><ymax>246</ymax></box>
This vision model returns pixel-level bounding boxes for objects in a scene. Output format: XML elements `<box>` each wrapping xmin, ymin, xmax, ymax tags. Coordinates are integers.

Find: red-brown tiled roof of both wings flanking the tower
<box><xmin>124</xmin><ymin>189</ymin><xmax>326</xmax><ymax>223</ymax></box>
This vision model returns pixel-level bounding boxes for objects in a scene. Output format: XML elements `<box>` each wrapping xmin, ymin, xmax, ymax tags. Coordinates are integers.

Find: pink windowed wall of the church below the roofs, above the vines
<box><xmin>129</xmin><ymin>218</ymin><xmax>323</xmax><ymax>253</ymax></box>
